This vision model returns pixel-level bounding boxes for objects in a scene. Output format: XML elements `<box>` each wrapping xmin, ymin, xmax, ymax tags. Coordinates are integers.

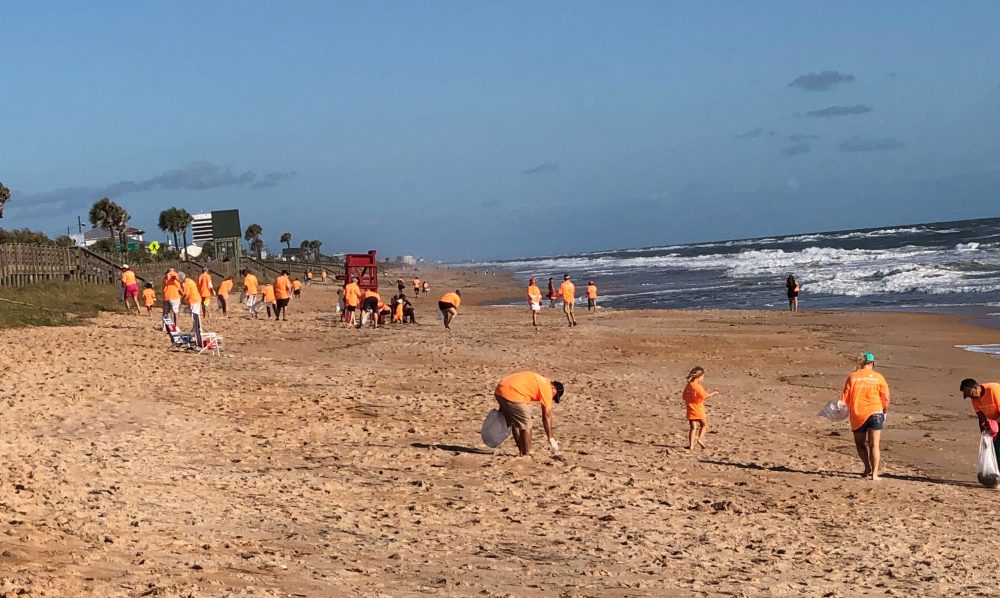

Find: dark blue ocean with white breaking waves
<box><xmin>465</xmin><ymin>218</ymin><xmax>1000</xmax><ymax>352</ymax></box>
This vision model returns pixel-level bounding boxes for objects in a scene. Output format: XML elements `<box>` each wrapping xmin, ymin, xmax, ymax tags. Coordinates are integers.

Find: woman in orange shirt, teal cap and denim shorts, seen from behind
<box><xmin>840</xmin><ymin>353</ymin><xmax>889</xmax><ymax>480</ymax></box>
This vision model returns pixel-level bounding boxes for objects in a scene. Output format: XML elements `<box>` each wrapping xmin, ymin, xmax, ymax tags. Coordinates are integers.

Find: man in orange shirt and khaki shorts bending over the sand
<box><xmin>493</xmin><ymin>372</ymin><xmax>563</xmax><ymax>457</ymax></box>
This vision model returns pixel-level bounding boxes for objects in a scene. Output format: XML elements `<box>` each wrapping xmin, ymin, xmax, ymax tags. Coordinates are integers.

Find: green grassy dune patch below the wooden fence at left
<box><xmin>0</xmin><ymin>281</ymin><xmax>122</xmax><ymax>328</ymax></box>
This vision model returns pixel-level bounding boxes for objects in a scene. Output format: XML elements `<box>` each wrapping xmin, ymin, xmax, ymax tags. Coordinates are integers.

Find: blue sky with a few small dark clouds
<box><xmin>0</xmin><ymin>0</ymin><xmax>1000</xmax><ymax>260</ymax></box>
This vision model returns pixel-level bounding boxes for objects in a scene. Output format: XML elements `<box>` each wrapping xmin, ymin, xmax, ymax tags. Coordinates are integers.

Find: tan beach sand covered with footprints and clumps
<box><xmin>0</xmin><ymin>271</ymin><xmax>1000</xmax><ymax>597</ymax></box>
